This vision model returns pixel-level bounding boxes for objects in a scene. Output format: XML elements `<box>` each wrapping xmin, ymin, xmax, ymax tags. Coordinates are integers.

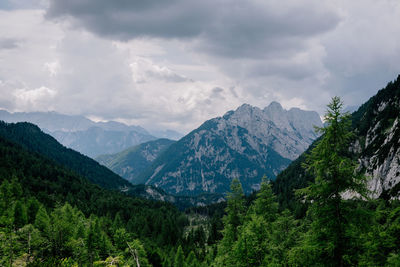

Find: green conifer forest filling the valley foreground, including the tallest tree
<box><xmin>0</xmin><ymin>93</ymin><xmax>400</xmax><ymax>267</ymax></box>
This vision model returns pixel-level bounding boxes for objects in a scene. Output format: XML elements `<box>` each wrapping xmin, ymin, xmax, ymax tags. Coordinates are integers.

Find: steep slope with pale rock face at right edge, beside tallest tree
<box><xmin>352</xmin><ymin>75</ymin><xmax>400</xmax><ymax>197</ymax></box>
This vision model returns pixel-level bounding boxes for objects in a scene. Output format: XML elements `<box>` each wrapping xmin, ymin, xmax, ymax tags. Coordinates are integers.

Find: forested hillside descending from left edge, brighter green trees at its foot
<box><xmin>0</xmin><ymin>133</ymin><xmax>192</xmax><ymax>266</ymax></box>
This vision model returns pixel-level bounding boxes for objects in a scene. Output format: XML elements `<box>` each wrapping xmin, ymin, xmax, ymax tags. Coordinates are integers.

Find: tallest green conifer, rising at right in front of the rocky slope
<box><xmin>298</xmin><ymin>97</ymin><xmax>365</xmax><ymax>266</ymax></box>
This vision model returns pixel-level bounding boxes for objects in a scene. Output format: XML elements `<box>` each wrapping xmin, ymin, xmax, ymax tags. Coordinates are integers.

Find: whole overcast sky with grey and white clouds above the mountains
<box><xmin>0</xmin><ymin>0</ymin><xmax>400</xmax><ymax>133</ymax></box>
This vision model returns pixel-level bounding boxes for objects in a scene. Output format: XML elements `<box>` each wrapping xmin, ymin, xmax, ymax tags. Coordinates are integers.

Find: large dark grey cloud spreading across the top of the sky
<box><xmin>47</xmin><ymin>0</ymin><xmax>339</xmax><ymax>58</ymax></box>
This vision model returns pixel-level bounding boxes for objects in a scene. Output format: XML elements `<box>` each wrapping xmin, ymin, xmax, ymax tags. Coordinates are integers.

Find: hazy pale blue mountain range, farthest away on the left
<box><xmin>0</xmin><ymin>110</ymin><xmax>182</xmax><ymax>157</ymax></box>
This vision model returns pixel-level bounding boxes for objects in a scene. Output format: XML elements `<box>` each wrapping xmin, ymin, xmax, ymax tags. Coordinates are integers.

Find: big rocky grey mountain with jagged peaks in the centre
<box><xmin>138</xmin><ymin>102</ymin><xmax>322</xmax><ymax>195</ymax></box>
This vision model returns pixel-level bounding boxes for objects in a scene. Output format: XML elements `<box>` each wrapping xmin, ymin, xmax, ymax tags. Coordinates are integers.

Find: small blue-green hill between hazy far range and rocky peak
<box><xmin>96</xmin><ymin>139</ymin><xmax>175</xmax><ymax>184</ymax></box>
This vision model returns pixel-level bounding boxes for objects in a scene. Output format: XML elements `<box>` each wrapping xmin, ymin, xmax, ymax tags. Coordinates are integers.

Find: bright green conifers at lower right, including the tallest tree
<box><xmin>208</xmin><ymin>95</ymin><xmax>400</xmax><ymax>266</ymax></box>
